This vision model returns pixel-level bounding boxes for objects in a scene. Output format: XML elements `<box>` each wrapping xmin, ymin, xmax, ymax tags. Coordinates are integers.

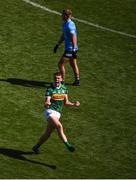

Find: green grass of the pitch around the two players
<box><xmin>0</xmin><ymin>0</ymin><xmax>136</xmax><ymax>179</ymax></box>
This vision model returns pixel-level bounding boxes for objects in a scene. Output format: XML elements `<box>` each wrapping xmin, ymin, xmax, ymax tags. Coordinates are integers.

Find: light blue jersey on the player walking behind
<box><xmin>63</xmin><ymin>19</ymin><xmax>78</xmax><ymax>51</ymax></box>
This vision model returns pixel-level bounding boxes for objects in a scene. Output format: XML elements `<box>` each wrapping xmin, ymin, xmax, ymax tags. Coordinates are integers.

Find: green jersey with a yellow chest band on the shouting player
<box><xmin>45</xmin><ymin>84</ymin><xmax>68</xmax><ymax>113</ymax></box>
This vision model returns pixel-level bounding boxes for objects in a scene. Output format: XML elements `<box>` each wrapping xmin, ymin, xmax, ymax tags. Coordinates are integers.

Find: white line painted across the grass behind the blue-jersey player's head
<box><xmin>22</xmin><ymin>0</ymin><xmax>136</xmax><ymax>39</ymax></box>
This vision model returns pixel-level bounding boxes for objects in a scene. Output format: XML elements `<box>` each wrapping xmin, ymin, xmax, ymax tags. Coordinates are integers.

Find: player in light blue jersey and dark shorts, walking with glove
<box><xmin>54</xmin><ymin>9</ymin><xmax>80</xmax><ymax>86</ymax></box>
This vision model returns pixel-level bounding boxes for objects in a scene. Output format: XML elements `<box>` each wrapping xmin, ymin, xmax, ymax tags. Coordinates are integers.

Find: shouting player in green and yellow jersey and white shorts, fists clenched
<box><xmin>32</xmin><ymin>72</ymin><xmax>80</xmax><ymax>154</ymax></box>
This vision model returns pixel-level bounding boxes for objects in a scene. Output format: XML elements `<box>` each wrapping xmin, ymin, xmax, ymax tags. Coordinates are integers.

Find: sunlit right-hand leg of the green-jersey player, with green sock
<box><xmin>50</xmin><ymin>117</ymin><xmax>75</xmax><ymax>152</ymax></box>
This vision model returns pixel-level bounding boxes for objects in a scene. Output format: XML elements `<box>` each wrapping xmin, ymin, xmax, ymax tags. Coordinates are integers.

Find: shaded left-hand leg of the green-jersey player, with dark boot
<box><xmin>32</xmin><ymin>121</ymin><xmax>55</xmax><ymax>154</ymax></box>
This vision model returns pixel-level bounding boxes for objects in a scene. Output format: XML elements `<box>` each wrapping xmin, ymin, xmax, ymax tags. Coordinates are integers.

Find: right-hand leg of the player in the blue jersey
<box><xmin>70</xmin><ymin>58</ymin><xmax>80</xmax><ymax>86</ymax></box>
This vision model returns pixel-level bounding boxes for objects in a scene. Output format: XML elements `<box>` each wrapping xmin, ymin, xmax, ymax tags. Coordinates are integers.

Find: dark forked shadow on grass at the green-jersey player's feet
<box><xmin>0</xmin><ymin>148</ymin><xmax>56</xmax><ymax>169</ymax></box>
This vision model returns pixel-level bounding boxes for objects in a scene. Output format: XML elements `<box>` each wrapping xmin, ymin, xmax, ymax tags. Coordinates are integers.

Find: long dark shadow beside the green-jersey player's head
<box><xmin>0</xmin><ymin>78</ymin><xmax>50</xmax><ymax>88</ymax></box>
